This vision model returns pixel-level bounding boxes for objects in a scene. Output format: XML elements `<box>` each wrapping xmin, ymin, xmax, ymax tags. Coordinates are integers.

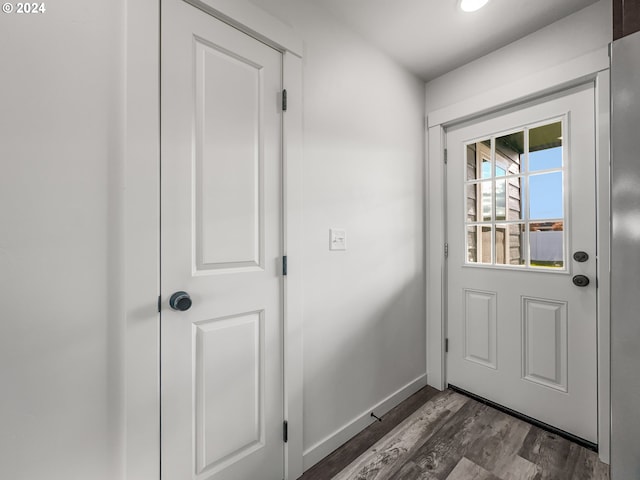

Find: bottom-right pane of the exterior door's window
<box><xmin>529</xmin><ymin>221</ymin><xmax>564</xmax><ymax>268</ymax></box>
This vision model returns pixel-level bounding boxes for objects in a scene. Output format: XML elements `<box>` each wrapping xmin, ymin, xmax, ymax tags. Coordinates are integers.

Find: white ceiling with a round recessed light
<box><xmin>252</xmin><ymin>0</ymin><xmax>597</xmax><ymax>81</ymax></box>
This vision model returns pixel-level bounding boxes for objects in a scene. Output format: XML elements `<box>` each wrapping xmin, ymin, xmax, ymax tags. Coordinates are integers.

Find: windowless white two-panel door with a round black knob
<box><xmin>161</xmin><ymin>0</ymin><xmax>284</xmax><ymax>480</ymax></box>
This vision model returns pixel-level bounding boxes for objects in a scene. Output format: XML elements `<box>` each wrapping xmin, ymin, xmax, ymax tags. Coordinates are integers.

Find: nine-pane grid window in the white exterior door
<box><xmin>464</xmin><ymin>119</ymin><xmax>567</xmax><ymax>271</ymax></box>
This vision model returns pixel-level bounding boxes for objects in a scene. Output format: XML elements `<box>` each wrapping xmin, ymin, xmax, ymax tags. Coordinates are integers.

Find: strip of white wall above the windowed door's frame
<box><xmin>426</xmin><ymin>0</ymin><xmax>612</xmax><ymax>113</ymax></box>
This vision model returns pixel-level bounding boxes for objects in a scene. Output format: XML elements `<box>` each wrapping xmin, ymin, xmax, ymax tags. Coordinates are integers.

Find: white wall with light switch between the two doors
<box><xmin>254</xmin><ymin>0</ymin><xmax>425</xmax><ymax>467</ymax></box>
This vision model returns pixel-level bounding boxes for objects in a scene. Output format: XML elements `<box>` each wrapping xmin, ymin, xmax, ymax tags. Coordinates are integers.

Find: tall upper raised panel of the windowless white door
<box><xmin>194</xmin><ymin>37</ymin><xmax>264</xmax><ymax>271</ymax></box>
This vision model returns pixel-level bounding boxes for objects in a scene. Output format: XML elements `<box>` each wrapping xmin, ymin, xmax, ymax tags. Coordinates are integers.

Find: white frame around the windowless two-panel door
<box><xmin>125</xmin><ymin>0</ymin><xmax>303</xmax><ymax>480</ymax></box>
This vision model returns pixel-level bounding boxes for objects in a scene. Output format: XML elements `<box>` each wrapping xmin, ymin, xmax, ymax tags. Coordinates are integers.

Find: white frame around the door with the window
<box><xmin>426</xmin><ymin>48</ymin><xmax>611</xmax><ymax>463</ymax></box>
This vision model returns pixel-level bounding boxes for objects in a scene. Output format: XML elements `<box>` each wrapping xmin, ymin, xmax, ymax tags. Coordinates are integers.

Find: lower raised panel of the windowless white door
<box><xmin>193</xmin><ymin>312</ymin><xmax>264</xmax><ymax>474</ymax></box>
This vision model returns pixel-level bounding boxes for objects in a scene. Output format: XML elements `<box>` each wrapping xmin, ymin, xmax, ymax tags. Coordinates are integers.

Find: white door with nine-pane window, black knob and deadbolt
<box><xmin>446</xmin><ymin>86</ymin><xmax>597</xmax><ymax>443</ymax></box>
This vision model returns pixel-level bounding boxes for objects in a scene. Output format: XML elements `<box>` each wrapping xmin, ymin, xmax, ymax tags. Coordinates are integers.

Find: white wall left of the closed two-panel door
<box><xmin>0</xmin><ymin>0</ymin><xmax>124</xmax><ymax>480</ymax></box>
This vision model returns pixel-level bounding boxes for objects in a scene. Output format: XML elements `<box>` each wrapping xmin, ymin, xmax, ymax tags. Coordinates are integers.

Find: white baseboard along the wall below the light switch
<box><xmin>302</xmin><ymin>374</ymin><xmax>427</xmax><ymax>470</ymax></box>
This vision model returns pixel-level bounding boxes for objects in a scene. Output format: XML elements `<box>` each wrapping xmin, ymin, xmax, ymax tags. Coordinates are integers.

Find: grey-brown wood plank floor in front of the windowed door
<box><xmin>300</xmin><ymin>387</ymin><xmax>609</xmax><ymax>480</ymax></box>
